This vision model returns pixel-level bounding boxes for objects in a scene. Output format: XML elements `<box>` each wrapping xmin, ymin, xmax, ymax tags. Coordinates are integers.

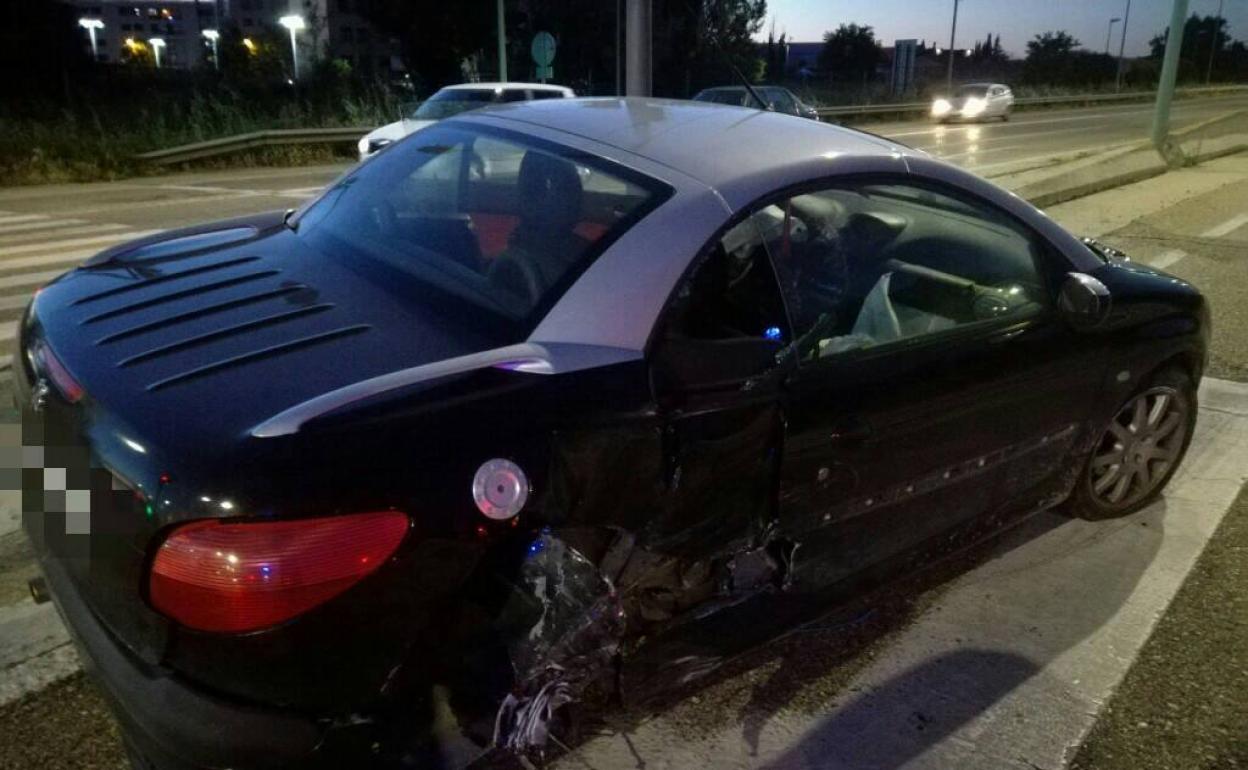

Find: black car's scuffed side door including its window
<box><xmin>753</xmin><ymin>177</ymin><xmax>1104</xmax><ymax>589</ymax></box>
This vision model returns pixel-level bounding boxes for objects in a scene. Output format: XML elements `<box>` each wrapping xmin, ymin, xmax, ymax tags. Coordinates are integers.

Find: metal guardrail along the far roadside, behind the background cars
<box><xmin>135</xmin><ymin>86</ymin><xmax>1248</xmax><ymax>166</ymax></box>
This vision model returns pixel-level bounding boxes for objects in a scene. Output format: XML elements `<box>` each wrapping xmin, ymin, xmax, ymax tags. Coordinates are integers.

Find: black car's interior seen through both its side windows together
<box><xmin>668</xmin><ymin>179</ymin><xmax>1048</xmax><ymax>378</ymax></box>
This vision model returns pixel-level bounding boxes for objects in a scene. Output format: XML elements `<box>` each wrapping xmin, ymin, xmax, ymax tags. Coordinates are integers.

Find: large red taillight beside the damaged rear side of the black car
<box><xmin>149</xmin><ymin>510</ymin><xmax>408</xmax><ymax>633</ymax></box>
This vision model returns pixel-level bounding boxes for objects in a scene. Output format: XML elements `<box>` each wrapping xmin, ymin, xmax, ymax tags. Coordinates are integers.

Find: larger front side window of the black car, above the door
<box><xmin>755</xmin><ymin>183</ymin><xmax>1048</xmax><ymax>361</ymax></box>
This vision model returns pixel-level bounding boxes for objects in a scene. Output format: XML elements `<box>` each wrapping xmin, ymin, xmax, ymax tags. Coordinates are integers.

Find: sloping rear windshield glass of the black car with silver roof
<box><xmin>292</xmin><ymin>122</ymin><xmax>670</xmax><ymax>343</ymax></box>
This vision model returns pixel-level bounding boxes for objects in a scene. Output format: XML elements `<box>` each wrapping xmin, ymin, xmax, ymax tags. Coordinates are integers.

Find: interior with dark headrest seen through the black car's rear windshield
<box><xmin>327</xmin><ymin>132</ymin><xmax>653</xmax><ymax>319</ymax></box>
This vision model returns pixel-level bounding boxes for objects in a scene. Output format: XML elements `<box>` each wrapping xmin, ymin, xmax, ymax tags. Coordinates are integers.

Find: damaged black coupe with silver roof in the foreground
<box><xmin>14</xmin><ymin>99</ymin><xmax>1209</xmax><ymax>769</ymax></box>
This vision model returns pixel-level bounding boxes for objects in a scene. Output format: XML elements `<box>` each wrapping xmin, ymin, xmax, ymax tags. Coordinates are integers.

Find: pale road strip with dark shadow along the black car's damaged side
<box><xmin>555</xmin><ymin>378</ymin><xmax>1248</xmax><ymax>770</ymax></box>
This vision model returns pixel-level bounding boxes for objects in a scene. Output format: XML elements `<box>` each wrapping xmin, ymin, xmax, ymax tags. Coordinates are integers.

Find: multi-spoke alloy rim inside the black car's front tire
<box><xmin>1087</xmin><ymin>387</ymin><xmax>1189</xmax><ymax>508</ymax></box>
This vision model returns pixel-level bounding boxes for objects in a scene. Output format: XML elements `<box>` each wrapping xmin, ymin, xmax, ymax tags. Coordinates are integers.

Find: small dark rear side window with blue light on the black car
<box><xmin>656</xmin><ymin>213</ymin><xmax>790</xmax><ymax>391</ymax></box>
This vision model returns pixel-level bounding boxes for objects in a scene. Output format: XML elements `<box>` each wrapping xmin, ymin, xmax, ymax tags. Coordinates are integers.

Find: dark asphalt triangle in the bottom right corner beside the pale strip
<box><xmin>1071</xmin><ymin>490</ymin><xmax>1248</xmax><ymax>770</ymax></box>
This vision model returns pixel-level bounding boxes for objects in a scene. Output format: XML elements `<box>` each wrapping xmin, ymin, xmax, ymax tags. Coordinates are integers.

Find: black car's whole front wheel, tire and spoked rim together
<box><xmin>1068</xmin><ymin>368</ymin><xmax>1197</xmax><ymax>520</ymax></box>
